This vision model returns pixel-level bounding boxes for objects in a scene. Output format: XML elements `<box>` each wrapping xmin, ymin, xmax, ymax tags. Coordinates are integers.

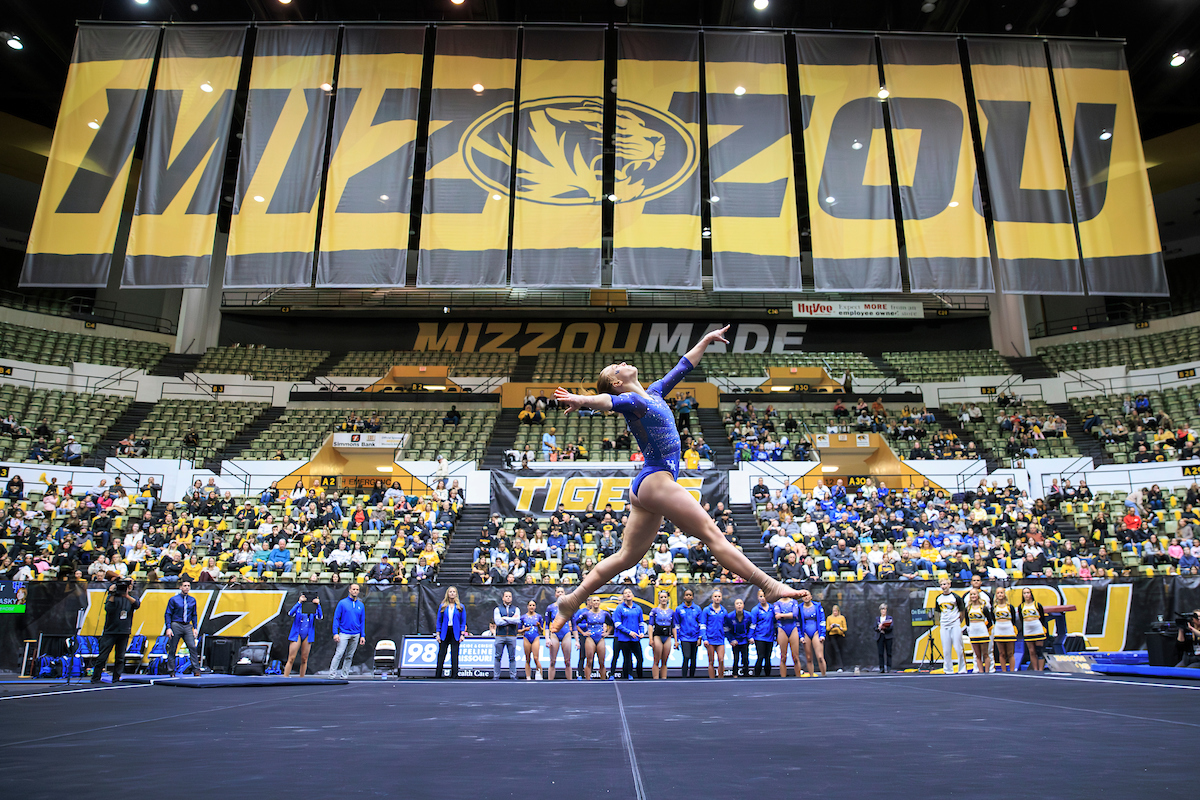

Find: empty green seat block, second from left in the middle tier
<box><xmin>133</xmin><ymin>399</ymin><xmax>268</xmax><ymax>458</ymax></box>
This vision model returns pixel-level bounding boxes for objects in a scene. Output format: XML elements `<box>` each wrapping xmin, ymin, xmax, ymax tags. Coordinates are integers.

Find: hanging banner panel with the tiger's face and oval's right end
<box><xmin>612</xmin><ymin>30</ymin><xmax>701</xmax><ymax>289</ymax></box>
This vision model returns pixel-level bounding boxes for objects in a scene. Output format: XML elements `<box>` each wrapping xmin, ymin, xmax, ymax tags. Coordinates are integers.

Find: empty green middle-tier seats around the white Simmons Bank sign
<box><xmin>240</xmin><ymin>403</ymin><xmax>498</xmax><ymax>461</ymax></box>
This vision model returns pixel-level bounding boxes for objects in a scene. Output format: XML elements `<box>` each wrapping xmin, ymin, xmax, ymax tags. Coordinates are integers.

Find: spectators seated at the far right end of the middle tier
<box><xmin>1084</xmin><ymin>393</ymin><xmax>1200</xmax><ymax>464</ymax></box>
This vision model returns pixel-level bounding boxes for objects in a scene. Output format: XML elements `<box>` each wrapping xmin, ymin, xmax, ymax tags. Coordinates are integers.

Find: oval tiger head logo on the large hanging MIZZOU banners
<box><xmin>460</xmin><ymin>97</ymin><xmax>697</xmax><ymax>205</ymax></box>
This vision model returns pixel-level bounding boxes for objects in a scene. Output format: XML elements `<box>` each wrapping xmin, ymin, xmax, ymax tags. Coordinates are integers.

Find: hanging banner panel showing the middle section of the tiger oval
<box><xmin>512</xmin><ymin>29</ymin><xmax>605</xmax><ymax>287</ymax></box>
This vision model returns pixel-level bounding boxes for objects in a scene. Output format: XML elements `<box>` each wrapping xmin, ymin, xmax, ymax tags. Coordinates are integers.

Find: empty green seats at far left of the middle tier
<box><xmin>0</xmin><ymin>385</ymin><xmax>132</xmax><ymax>461</ymax></box>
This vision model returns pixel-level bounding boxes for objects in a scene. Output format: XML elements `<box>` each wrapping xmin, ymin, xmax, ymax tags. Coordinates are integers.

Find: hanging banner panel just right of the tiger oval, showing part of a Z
<box><xmin>704</xmin><ymin>32</ymin><xmax>802</xmax><ymax>291</ymax></box>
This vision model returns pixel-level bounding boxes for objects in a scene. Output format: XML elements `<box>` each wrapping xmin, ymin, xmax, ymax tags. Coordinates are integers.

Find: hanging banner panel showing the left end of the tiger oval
<box><xmin>416</xmin><ymin>28</ymin><xmax>517</xmax><ymax>287</ymax></box>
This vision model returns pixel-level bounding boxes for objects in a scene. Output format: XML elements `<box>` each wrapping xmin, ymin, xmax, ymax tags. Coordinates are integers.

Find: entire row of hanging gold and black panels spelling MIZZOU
<box><xmin>22</xmin><ymin>24</ymin><xmax>1168</xmax><ymax>296</ymax></box>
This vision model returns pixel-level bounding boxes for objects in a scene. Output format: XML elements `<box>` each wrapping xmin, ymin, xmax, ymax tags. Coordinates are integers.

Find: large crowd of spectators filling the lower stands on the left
<box><xmin>0</xmin><ymin>475</ymin><xmax>463</xmax><ymax>583</ymax></box>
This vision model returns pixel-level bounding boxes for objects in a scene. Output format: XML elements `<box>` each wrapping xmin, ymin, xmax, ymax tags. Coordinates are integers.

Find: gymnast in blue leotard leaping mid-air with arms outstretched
<box><xmin>551</xmin><ymin>325</ymin><xmax>797</xmax><ymax>631</ymax></box>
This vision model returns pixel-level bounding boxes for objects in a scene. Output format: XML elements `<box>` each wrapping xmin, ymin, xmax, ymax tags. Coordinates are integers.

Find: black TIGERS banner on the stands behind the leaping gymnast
<box><xmin>492</xmin><ymin>469</ymin><xmax>730</xmax><ymax>517</ymax></box>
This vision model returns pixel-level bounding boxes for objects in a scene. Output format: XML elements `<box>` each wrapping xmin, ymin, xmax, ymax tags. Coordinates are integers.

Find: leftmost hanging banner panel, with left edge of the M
<box><xmin>20</xmin><ymin>24</ymin><xmax>160</xmax><ymax>287</ymax></box>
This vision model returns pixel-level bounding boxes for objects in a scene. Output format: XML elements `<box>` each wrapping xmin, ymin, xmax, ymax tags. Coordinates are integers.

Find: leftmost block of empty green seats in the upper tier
<box><xmin>0</xmin><ymin>325</ymin><xmax>167</xmax><ymax>369</ymax></box>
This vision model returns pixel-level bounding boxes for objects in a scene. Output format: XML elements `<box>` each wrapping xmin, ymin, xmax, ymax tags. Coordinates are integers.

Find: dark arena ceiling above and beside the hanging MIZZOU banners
<box><xmin>7</xmin><ymin>0</ymin><xmax>1200</xmax><ymax>139</ymax></box>
